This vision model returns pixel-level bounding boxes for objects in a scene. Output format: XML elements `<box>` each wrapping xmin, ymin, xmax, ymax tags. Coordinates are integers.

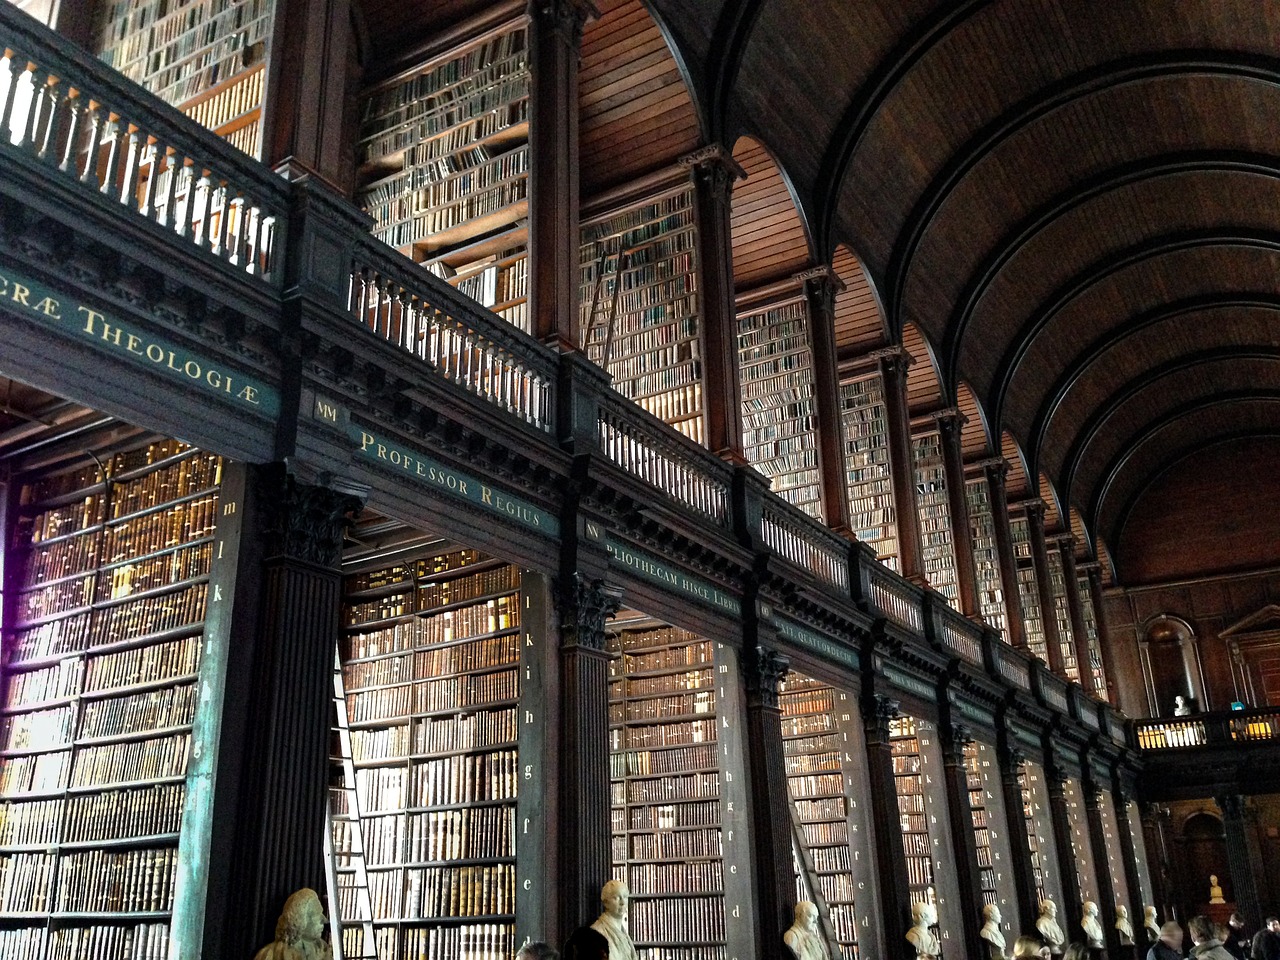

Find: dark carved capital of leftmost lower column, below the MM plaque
<box><xmin>256</xmin><ymin>463</ymin><xmax>364</xmax><ymax>570</ymax></box>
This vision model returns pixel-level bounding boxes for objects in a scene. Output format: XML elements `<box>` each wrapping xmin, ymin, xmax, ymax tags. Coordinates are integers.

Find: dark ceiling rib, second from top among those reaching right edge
<box><xmin>941</xmin><ymin>151</ymin><xmax>1280</xmax><ymax>374</ymax></box>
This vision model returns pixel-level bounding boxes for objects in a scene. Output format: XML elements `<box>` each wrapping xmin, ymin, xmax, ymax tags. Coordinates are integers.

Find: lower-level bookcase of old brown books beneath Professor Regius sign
<box><xmin>330</xmin><ymin>550</ymin><xmax>524</xmax><ymax>960</ymax></box>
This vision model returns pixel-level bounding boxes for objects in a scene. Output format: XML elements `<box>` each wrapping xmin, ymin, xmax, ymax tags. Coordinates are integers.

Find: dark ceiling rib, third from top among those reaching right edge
<box><xmin>987</xmin><ymin>229</ymin><xmax>1280</xmax><ymax>424</ymax></box>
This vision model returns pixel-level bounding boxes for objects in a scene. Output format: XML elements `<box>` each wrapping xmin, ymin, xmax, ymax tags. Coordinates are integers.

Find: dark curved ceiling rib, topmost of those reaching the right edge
<box><xmin>882</xmin><ymin>50</ymin><xmax>1280</xmax><ymax>330</ymax></box>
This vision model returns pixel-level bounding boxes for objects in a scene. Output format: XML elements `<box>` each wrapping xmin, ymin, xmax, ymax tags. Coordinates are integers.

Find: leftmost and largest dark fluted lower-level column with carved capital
<box><xmin>204</xmin><ymin>463</ymin><xmax>360</xmax><ymax>956</ymax></box>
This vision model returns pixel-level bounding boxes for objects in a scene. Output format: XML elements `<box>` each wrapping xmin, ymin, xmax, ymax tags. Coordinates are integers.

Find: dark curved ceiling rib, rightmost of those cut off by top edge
<box><xmin>814</xmin><ymin>0</ymin><xmax>992</xmax><ymax>259</ymax></box>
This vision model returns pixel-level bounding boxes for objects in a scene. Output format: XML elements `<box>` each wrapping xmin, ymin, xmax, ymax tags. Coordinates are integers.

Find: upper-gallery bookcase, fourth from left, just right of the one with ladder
<box><xmin>737</xmin><ymin>298</ymin><xmax>822</xmax><ymax>520</ymax></box>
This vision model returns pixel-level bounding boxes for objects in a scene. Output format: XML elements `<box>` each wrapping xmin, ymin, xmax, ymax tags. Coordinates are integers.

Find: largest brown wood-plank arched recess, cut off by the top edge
<box><xmin>577</xmin><ymin>0</ymin><xmax>703</xmax><ymax>197</ymax></box>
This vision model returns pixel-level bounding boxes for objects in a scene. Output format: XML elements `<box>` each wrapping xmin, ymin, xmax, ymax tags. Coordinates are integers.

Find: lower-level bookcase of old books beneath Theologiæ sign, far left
<box><xmin>0</xmin><ymin>440</ymin><xmax>224</xmax><ymax>960</ymax></box>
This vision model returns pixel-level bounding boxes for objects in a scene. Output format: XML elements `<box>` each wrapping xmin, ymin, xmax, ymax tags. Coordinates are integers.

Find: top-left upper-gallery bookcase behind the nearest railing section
<box><xmin>96</xmin><ymin>0</ymin><xmax>275</xmax><ymax>157</ymax></box>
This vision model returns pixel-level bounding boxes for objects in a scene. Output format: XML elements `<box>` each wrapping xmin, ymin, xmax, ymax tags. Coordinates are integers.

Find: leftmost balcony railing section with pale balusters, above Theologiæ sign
<box><xmin>0</xmin><ymin>4</ymin><xmax>289</xmax><ymax>285</ymax></box>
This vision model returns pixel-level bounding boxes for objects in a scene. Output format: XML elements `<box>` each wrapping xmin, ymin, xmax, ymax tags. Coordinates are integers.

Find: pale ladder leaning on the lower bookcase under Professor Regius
<box><xmin>324</xmin><ymin>646</ymin><xmax>378</xmax><ymax>960</ymax></box>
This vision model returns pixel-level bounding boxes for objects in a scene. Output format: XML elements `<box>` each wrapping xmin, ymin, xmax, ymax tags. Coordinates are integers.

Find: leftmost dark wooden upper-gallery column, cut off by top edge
<box><xmin>261</xmin><ymin>0</ymin><xmax>360</xmax><ymax>189</ymax></box>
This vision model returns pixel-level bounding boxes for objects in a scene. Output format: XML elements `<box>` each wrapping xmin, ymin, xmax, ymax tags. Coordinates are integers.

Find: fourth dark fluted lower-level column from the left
<box><xmin>861</xmin><ymin>694</ymin><xmax>911</xmax><ymax>956</ymax></box>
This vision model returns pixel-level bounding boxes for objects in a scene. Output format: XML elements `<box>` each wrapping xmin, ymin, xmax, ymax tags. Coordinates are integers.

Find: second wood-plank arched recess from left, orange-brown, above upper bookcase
<box><xmin>730</xmin><ymin>137</ymin><xmax>813</xmax><ymax>293</ymax></box>
